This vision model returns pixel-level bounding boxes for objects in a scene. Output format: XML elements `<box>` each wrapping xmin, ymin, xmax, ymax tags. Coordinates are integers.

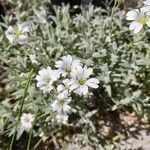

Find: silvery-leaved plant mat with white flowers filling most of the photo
<box><xmin>0</xmin><ymin>0</ymin><xmax>150</xmax><ymax>149</ymax></box>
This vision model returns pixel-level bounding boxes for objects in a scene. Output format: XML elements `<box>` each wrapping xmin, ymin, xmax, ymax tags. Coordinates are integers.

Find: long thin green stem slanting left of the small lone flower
<box><xmin>9</xmin><ymin>69</ymin><xmax>33</xmax><ymax>150</ymax></box>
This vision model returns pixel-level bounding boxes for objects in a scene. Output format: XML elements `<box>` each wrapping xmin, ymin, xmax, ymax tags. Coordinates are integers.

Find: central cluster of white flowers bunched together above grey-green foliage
<box><xmin>36</xmin><ymin>55</ymin><xmax>99</xmax><ymax>124</ymax></box>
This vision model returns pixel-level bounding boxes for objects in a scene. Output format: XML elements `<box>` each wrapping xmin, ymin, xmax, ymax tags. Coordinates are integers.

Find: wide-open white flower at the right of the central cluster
<box><xmin>70</xmin><ymin>66</ymin><xmax>99</xmax><ymax>95</ymax></box>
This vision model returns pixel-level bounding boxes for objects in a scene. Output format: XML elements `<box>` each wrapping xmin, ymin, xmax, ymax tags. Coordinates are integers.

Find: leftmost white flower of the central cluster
<box><xmin>36</xmin><ymin>67</ymin><xmax>59</xmax><ymax>93</ymax></box>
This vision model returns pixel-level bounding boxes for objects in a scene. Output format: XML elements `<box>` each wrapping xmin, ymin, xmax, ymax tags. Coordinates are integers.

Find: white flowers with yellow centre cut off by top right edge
<box><xmin>126</xmin><ymin>0</ymin><xmax>150</xmax><ymax>33</ymax></box>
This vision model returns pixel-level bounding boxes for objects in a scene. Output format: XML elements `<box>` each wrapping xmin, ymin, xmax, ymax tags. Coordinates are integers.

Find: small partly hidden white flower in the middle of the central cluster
<box><xmin>57</xmin><ymin>79</ymin><xmax>70</xmax><ymax>98</ymax></box>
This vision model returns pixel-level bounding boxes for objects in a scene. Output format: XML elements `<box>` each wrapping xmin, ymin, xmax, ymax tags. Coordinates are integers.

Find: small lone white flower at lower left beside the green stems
<box><xmin>21</xmin><ymin>113</ymin><xmax>34</xmax><ymax>130</ymax></box>
